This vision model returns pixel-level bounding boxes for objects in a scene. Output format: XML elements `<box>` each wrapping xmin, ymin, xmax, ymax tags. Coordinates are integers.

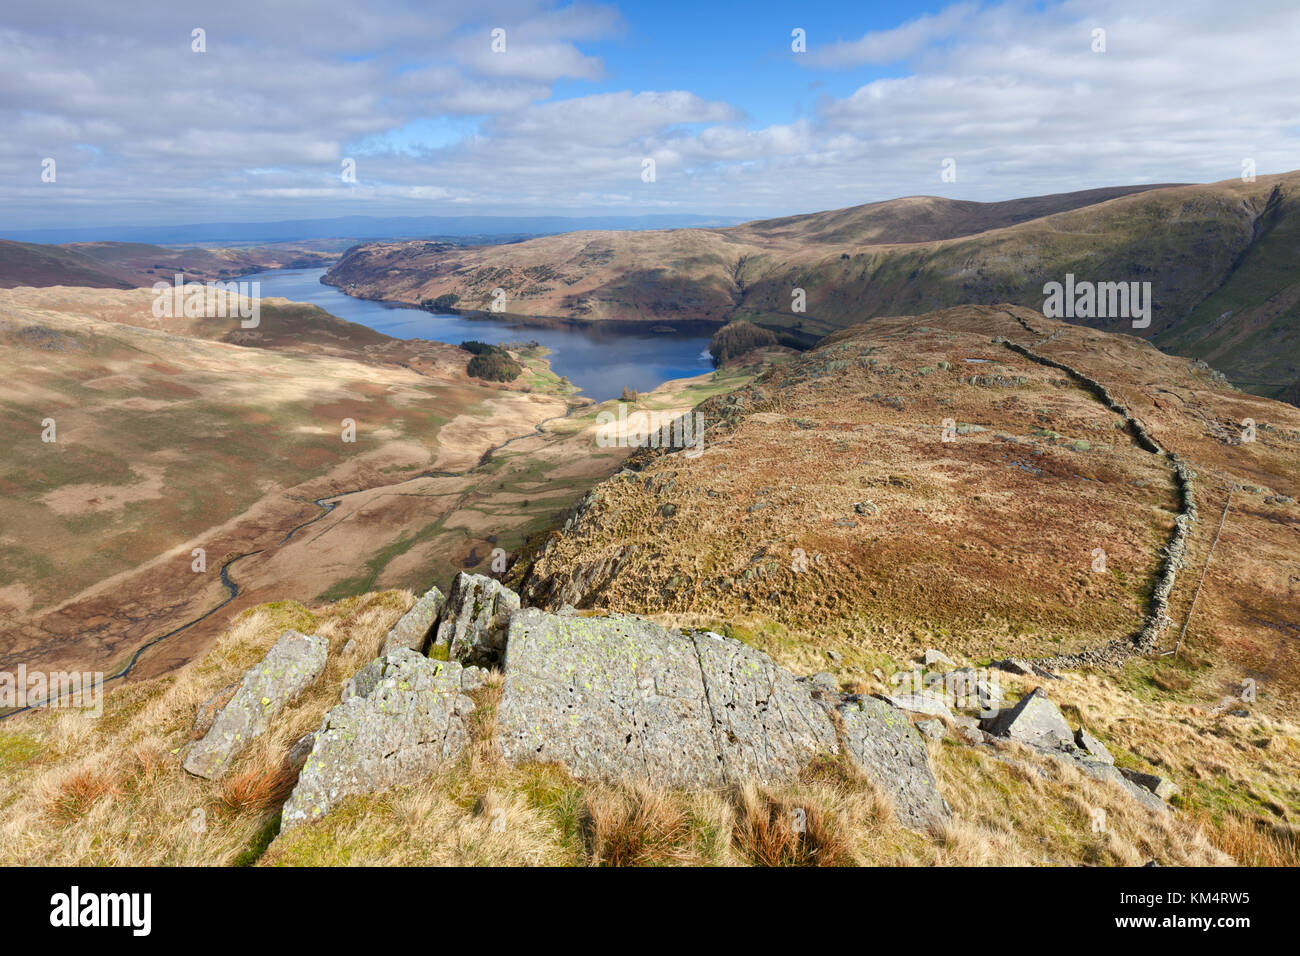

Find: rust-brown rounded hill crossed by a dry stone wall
<box><xmin>520</xmin><ymin>307</ymin><xmax>1300</xmax><ymax>712</ymax></box>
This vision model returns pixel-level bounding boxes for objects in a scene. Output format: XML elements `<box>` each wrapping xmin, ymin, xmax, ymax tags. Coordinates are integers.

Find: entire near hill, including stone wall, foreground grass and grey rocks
<box><xmin>0</xmin><ymin>306</ymin><xmax>1300</xmax><ymax>866</ymax></box>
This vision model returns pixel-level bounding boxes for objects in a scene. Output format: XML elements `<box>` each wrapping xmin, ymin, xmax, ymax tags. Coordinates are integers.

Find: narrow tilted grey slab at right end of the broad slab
<box><xmin>839</xmin><ymin>696</ymin><xmax>950</xmax><ymax>829</ymax></box>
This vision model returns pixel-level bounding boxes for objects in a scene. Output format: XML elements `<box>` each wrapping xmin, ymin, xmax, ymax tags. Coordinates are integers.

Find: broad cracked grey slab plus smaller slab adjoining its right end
<box><xmin>497</xmin><ymin>609</ymin><xmax>943</xmax><ymax>825</ymax></box>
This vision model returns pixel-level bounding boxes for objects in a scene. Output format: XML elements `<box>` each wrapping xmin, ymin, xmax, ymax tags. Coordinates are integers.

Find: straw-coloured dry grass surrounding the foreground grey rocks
<box><xmin>0</xmin><ymin>592</ymin><xmax>1300</xmax><ymax>866</ymax></box>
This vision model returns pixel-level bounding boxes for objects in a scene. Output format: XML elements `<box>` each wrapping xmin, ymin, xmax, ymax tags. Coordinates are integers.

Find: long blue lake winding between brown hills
<box><xmin>241</xmin><ymin>269</ymin><xmax>712</xmax><ymax>402</ymax></box>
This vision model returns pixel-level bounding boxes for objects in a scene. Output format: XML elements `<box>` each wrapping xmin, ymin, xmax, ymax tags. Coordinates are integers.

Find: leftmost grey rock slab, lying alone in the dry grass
<box><xmin>185</xmin><ymin>631</ymin><xmax>329</xmax><ymax>779</ymax></box>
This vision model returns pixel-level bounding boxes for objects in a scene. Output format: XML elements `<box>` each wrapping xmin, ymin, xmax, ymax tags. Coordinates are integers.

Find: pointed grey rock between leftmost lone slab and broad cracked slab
<box><xmin>281</xmin><ymin>648</ymin><xmax>475</xmax><ymax>830</ymax></box>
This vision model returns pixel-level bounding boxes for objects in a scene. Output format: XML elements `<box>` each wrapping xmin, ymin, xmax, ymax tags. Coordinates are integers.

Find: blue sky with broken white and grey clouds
<box><xmin>0</xmin><ymin>0</ymin><xmax>1300</xmax><ymax>235</ymax></box>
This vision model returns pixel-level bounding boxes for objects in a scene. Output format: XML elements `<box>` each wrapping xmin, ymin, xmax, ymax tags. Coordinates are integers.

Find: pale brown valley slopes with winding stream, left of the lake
<box><xmin>0</xmin><ymin>287</ymin><xmax>753</xmax><ymax>674</ymax></box>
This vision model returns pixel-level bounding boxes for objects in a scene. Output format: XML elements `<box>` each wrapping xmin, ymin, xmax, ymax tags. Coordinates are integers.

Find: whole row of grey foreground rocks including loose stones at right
<box><xmin>185</xmin><ymin>574</ymin><xmax>1196</xmax><ymax>830</ymax></box>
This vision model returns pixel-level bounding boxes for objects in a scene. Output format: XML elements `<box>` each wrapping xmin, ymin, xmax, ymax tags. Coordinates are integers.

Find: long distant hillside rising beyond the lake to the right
<box><xmin>326</xmin><ymin>173</ymin><xmax>1300</xmax><ymax>397</ymax></box>
